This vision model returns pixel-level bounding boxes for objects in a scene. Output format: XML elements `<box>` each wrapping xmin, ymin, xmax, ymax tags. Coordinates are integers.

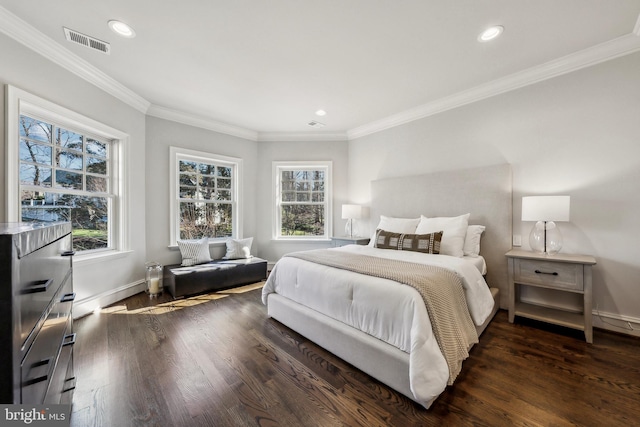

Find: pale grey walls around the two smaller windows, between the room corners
<box><xmin>146</xmin><ymin>121</ymin><xmax>348</xmax><ymax>265</ymax></box>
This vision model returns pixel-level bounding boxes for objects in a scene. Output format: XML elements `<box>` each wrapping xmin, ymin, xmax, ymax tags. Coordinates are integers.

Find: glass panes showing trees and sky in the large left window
<box><xmin>19</xmin><ymin>115</ymin><xmax>114</xmax><ymax>251</ymax></box>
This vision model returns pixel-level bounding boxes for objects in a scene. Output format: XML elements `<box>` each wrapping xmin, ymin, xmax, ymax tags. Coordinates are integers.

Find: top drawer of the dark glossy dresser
<box><xmin>19</xmin><ymin>234</ymin><xmax>71</xmax><ymax>343</ymax></box>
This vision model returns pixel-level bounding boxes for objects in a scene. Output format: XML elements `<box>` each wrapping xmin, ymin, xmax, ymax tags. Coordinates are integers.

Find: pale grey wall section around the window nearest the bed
<box><xmin>255</xmin><ymin>141</ymin><xmax>349</xmax><ymax>262</ymax></box>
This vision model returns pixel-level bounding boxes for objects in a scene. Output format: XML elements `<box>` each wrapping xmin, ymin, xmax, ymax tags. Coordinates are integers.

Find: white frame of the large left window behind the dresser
<box><xmin>5</xmin><ymin>85</ymin><xmax>130</xmax><ymax>262</ymax></box>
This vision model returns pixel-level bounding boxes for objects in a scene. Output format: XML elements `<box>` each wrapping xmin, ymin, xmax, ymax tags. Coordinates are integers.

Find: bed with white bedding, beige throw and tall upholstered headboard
<box><xmin>262</xmin><ymin>165</ymin><xmax>511</xmax><ymax>408</ymax></box>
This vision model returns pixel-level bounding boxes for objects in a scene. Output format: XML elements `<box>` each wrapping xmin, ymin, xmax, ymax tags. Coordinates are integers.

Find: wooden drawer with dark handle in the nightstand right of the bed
<box><xmin>514</xmin><ymin>259</ymin><xmax>584</xmax><ymax>291</ymax></box>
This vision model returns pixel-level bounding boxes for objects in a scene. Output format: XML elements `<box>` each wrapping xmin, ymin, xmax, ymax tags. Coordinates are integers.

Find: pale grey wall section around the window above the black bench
<box><xmin>145</xmin><ymin>116</ymin><xmax>261</xmax><ymax>265</ymax></box>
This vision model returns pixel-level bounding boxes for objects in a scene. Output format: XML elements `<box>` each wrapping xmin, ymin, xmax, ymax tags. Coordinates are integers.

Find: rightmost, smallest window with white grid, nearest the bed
<box><xmin>273</xmin><ymin>162</ymin><xmax>332</xmax><ymax>240</ymax></box>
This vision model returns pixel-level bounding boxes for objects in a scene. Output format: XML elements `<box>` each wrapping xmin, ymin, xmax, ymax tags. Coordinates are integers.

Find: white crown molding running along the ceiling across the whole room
<box><xmin>5</xmin><ymin>6</ymin><xmax>640</xmax><ymax>141</ymax></box>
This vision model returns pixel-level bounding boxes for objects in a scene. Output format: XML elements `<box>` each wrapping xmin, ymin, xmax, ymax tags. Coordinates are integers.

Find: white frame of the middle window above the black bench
<box><xmin>169</xmin><ymin>147</ymin><xmax>243</xmax><ymax>248</ymax></box>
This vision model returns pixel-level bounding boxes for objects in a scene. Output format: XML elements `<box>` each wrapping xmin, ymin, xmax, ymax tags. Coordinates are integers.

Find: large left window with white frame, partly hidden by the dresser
<box><xmin>7</xmin><ymin>87</ymin><xmax>128</xmax><ymax>255</ymax></box>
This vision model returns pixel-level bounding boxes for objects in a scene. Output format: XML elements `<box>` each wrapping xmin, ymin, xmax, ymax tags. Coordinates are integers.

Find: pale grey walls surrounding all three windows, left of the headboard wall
<box><xmin>0</xmin><ymin>27</ymin><xmax>348</xmax><ymax>315</ymax></box>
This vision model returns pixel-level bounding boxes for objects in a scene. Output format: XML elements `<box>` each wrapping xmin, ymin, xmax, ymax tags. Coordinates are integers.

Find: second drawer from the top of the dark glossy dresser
<box><xmin>21</xmin><ymin>277</ymin><xmax>75</xmax><ymax>403</ymax></box>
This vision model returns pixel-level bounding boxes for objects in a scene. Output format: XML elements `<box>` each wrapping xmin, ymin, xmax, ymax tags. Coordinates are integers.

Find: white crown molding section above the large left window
<box><xmin>0</xmin><ymin>6</ymin><xmax>150</xmax><ymax>113</ymax></box>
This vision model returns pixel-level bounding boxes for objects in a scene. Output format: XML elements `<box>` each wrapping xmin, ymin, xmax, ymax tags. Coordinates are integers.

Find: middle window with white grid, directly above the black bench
<box><xmin>170</xmin><ymin>147</ymin><xmax>242</xmax><ymax>245</ymax></box>
